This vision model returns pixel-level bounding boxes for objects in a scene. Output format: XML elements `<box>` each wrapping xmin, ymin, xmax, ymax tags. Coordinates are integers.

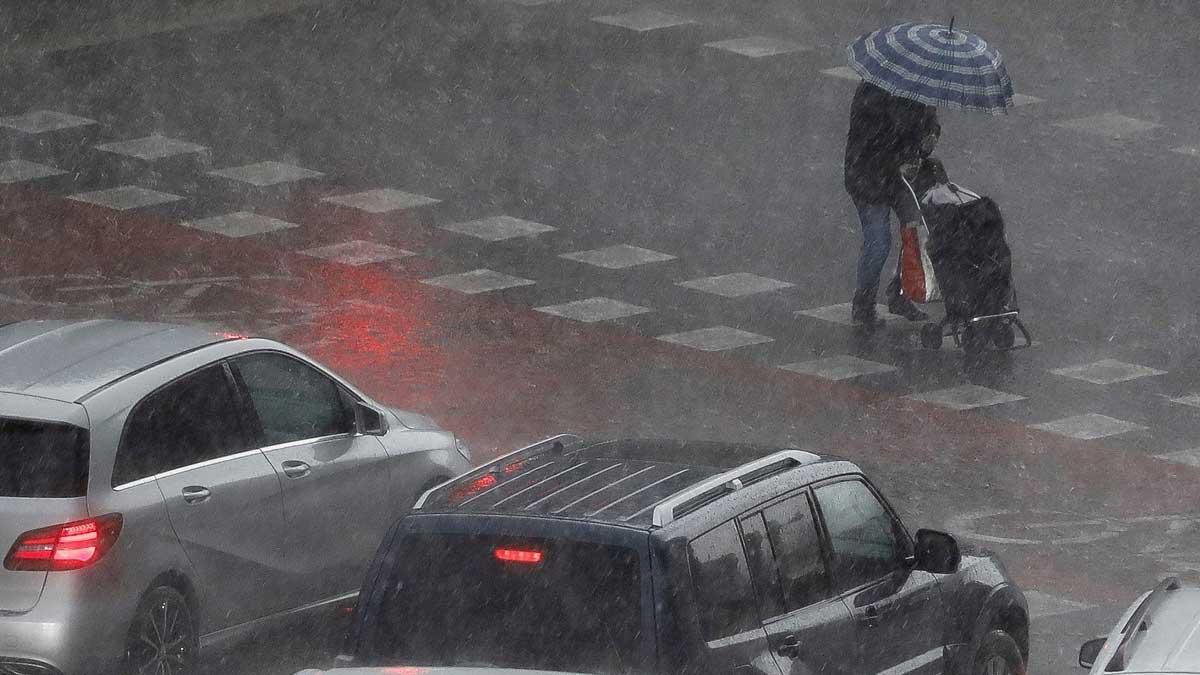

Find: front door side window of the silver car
<box><xmin>232</xmin><ymin>352</ymin><xmax>354</xmax><ymax>446</ymax></box>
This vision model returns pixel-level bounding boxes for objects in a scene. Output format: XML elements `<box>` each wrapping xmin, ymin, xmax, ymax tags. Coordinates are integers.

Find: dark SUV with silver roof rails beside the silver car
<box><xmin>338</xmin><ymin>435</ymin><xmax>1028</xmax><ymax>675</ymax></box>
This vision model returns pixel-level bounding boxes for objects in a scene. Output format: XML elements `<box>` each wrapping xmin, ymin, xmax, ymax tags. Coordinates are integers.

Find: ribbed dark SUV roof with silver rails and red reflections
<box><xmin>414</xmin><ymin>435</ymin><xmax>857</xmax><ymax>528</ymax></box>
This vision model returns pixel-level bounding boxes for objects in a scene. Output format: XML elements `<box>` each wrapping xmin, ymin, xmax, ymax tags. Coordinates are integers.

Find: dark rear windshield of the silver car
<box><xmin>0</xmin><ymin>417</ymin><xmax>88</xmax><ymax>497</ymax></box>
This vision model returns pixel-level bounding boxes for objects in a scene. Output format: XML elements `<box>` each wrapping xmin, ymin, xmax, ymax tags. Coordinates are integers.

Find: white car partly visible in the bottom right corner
<box><xmin>1079</xmin><ymin>577</ymin><xmax>1200</xmax><ymax>675</ymax></box>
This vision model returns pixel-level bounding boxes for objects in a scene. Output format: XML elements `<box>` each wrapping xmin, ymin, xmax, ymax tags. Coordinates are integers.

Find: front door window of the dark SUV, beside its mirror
<box><xmin>816</xmin><ymin>480</ymin><xmax>907</xmax><ymax>591</ymax></box>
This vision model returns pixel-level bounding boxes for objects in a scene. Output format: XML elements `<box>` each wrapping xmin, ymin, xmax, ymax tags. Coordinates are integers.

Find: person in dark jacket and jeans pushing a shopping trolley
<box><xmin>845</xmin><ymin>80</ymin><xmax>942</xmax><ymax>328</ymax></box>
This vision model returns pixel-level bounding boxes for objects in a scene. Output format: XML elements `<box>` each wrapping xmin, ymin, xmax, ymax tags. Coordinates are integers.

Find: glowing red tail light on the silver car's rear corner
<box><xmin>4</xmin><ymin>513</ymin><xmax>122</xmax><ymax>572</ymax></box>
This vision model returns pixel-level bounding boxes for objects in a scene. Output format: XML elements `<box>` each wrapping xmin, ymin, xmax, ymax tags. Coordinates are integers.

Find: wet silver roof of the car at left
<box><xmin>0</xmin><ymin>319</ymin><xmax>230</xmax><ymax>402</ymax></box>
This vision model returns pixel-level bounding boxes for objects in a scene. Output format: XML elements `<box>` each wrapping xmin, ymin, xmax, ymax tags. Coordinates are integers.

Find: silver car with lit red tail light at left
<box><xmin>0</xmin><ymin>321</ymin><xmax>469</xmax><ymax>675</ymax></box>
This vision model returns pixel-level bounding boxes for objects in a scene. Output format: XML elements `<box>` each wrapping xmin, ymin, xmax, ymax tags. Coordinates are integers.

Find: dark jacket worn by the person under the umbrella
<box><xmin>845</xmin><ymin>82</ymin><xmax>942</xmax><ymax>208</ymax></box>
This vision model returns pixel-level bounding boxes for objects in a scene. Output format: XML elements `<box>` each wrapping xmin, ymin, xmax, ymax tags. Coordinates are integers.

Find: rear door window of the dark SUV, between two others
<box><xmin>763</xmin><ymin>492</ymin><xmax>829</xmax><ymax>611</ymax></box>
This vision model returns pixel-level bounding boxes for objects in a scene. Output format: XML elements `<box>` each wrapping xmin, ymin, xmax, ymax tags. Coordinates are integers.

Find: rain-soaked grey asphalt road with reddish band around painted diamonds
<box><xmin>0</xmin><ymin>0</ymin><xmax>1200</xmax><ymax>673</ymax></box>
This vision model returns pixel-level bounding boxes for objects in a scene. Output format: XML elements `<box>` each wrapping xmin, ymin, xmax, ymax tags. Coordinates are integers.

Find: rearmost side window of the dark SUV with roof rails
<box><xmin>688</xmin><ymin>520</ymin><xmax>758</xmax><ymax>640</ymax></box>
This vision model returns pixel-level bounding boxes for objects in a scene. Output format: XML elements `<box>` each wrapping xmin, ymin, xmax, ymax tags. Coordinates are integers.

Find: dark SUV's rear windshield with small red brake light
<box><xmin>367</xmin><ymin>534</ymin><xmax>644</xmax><ymax>674</ymax></box>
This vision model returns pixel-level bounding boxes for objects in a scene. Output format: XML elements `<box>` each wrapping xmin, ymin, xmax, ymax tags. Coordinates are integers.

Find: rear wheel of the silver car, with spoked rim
<box><xmin>121</xmin><ymin>586</ymin><xmax>199</xmax><ymax>675</ymax></box>
